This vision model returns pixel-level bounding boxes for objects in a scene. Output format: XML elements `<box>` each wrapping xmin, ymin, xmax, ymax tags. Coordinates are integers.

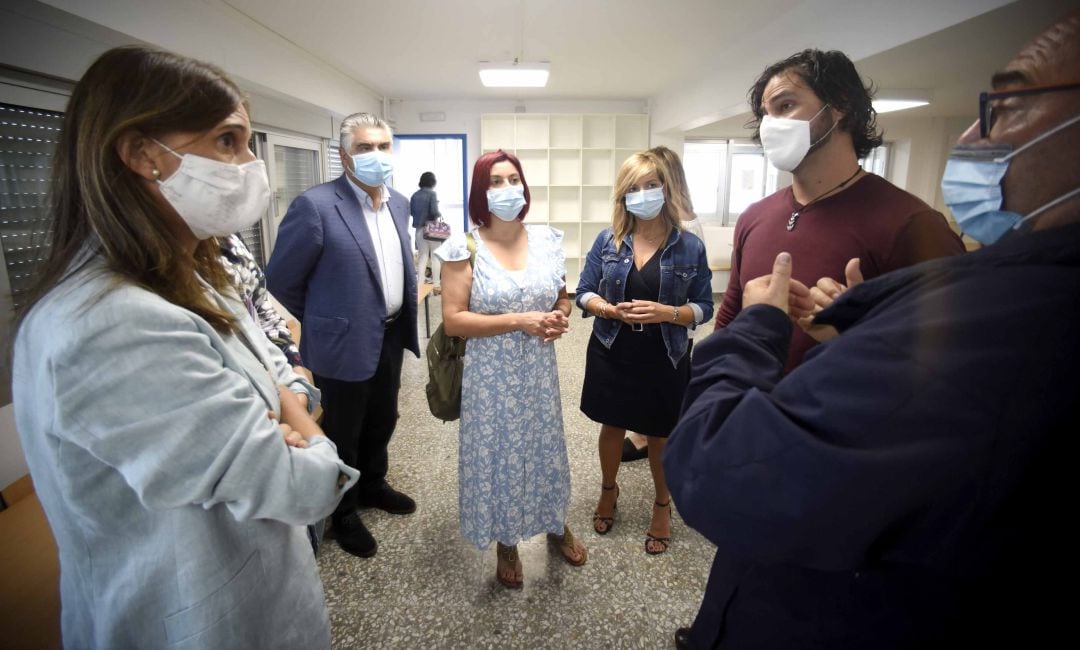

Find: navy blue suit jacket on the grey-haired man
<box><xmin>267</xmin><ymin>174</ymin><xmax>420</xmax><ymax>381</ymax></box>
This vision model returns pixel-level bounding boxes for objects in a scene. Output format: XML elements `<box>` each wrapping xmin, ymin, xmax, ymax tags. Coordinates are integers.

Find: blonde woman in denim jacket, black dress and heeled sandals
<box><xmin>577</xmin><ymin>151</ymin><xmax>713</xmax><ymax>555</ymax></box>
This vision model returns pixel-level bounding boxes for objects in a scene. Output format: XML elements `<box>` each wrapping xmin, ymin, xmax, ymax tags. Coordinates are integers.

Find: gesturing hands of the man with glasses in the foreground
<box><xmin>743</xmin><ymin>253</ymin><xmax>863</xmax><ymax>342</ymax></box>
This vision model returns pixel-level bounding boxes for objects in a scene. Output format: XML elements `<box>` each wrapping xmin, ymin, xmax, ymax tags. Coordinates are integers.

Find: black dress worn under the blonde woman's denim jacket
<box><xmin>581</xmin><ymin>252</ymin><xmax>692</xmax><ymax>437</ymax></box>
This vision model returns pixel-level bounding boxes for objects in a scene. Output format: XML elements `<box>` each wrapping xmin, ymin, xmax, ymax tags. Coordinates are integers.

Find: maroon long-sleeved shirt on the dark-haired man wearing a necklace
<box><xmin>716</xmin><ymin>174</ymin><xmax>963</xmax><ymax>371</ymax></box>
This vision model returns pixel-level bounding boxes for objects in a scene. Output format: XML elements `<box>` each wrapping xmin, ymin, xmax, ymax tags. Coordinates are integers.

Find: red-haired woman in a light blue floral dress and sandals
<box><xmin>435</xmin><ymin>150</ymin><xmax>588</xmax><ymax>587</ymax></box>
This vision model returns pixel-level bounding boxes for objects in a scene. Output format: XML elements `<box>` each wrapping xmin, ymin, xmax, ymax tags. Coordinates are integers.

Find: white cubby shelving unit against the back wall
<box><xmin>481</xmin><ymin>113</ymin><xmax>649</xmax><ymax>294</ymax></box>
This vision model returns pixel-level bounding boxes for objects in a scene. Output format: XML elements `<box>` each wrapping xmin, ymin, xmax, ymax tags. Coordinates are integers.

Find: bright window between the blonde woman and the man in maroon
<box><xmin>683</xmin><ymin>140</ymin><xmax>778</xmax><ymax>226</ymax></box>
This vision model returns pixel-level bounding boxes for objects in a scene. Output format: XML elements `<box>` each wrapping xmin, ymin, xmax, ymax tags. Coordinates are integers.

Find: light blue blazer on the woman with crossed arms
<box><xmin>13</xmin><ymin>251</ymin><xmax>357</xmax><ymax>648</ymax></box>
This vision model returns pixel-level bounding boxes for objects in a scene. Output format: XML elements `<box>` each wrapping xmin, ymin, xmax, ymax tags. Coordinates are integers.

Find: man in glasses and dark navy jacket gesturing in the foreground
<box><xmin>664</xmin><ymin>12</ymin><xmax>1080</xmax><ymax>649</ymax></box>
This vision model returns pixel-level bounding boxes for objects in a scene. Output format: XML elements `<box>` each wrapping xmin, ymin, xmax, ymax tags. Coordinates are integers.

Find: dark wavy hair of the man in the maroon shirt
<box><xmin>747</xmin><ymin>50</ymin><xmax>882</xmax><ymax>158</ymax></box>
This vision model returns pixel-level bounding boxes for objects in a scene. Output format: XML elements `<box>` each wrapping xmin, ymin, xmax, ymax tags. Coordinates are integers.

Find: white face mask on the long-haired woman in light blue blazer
<box><xmin>151</xmin><ymin>138</ymin><xmax>270</xmax><ymax>240</ymax></box>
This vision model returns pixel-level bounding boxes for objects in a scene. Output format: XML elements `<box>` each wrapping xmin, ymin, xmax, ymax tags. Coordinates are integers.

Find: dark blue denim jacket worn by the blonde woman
<box><xmin>577</xmin><ymin>228</ymin><xmax>713</xmax><ymax>366</ymax></box>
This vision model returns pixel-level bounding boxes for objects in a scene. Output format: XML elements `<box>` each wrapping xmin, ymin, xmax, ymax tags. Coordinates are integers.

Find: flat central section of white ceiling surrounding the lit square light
<box><xmin>225</xmin><ymin>0</ymin><xmax>804</xmax><ymax>99</ymax></box>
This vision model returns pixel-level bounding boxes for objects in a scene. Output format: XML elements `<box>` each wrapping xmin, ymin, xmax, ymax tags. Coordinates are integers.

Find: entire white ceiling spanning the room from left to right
<box><xmin>23</xmin><ymin>0</ymin><xmax>1080</xmax><ymax>136</ymax></box>
